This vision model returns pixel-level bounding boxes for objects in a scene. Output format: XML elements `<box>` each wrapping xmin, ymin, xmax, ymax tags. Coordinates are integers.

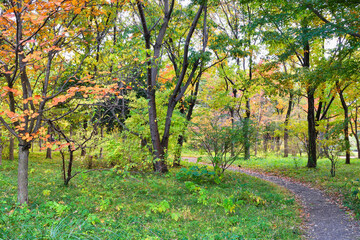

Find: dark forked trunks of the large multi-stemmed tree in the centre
<box><xmin>136</xmin><ymin>0</ymin><xmax>207</xmax><ymax>173</ymax></box>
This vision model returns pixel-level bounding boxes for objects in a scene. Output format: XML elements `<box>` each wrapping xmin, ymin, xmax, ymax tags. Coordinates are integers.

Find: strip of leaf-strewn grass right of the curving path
<box><xmin>231</xmin><ymin>155</ymin><xmax>360</xmax><ymax>219</ymax></box>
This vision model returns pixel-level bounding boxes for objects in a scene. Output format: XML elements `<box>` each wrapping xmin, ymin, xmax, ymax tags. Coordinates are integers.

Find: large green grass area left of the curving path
<box><xmin>0</xmin><ymin>152</ymin><xmax>302</xmax><ymax>239</ymax></box>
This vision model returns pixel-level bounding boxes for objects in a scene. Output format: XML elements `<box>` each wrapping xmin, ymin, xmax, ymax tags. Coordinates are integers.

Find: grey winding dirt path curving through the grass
<box><xmin>184</xmin><ymin>157</ymin><xmax>360</xmax><ymax>240</ymax></box>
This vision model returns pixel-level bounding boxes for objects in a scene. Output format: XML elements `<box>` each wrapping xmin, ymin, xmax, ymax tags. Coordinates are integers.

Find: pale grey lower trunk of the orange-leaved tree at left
<box><xmin>18</xmin><ymin>141</ymin><xmax>31</xmax><ymax>204</ymax></box>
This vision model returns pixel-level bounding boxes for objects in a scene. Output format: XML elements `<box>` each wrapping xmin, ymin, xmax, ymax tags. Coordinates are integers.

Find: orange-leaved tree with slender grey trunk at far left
<box><xmin>0</xmin><ymin>0</ymin><xmax>116</xmax><ymax>203</ymax></box>
